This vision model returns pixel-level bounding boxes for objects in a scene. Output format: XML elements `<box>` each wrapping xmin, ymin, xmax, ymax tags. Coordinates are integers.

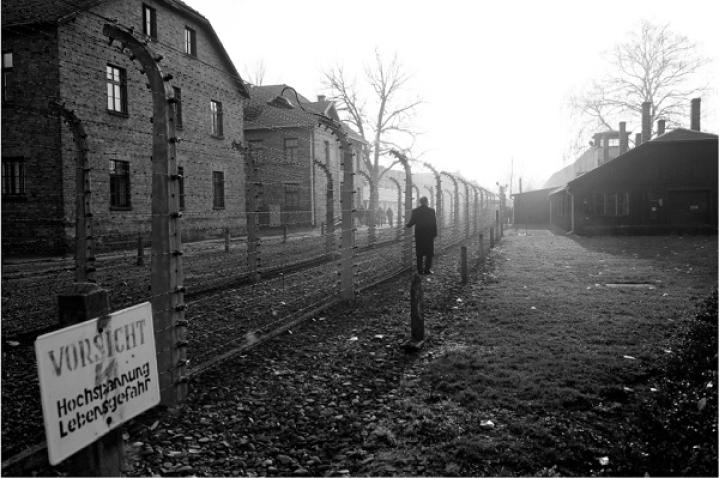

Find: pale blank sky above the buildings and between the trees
<box><xmin>185</xmin><ymin>0</ymin><xmax>719</xmax><ymax>190</ymax></box>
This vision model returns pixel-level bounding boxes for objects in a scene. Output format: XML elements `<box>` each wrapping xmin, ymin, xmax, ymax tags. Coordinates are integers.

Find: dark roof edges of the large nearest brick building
<box><xmin>2</xmin><ymin>0</ymin><xmax>249</xmax><ymax>98</ymax></box>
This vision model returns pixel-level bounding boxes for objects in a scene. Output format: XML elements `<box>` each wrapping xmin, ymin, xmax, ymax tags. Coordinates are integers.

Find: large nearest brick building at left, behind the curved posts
<box><xmin>2</xmin><ymin>0</ymin><xmax>248</xmax><ymax>254</ymax></box>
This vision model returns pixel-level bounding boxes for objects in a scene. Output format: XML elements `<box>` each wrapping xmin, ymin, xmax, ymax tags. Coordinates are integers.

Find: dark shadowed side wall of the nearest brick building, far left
<box><xmin>2</xmin><ymin>26</ymin><xmax>68</xmax><ymax>255</ymax></box>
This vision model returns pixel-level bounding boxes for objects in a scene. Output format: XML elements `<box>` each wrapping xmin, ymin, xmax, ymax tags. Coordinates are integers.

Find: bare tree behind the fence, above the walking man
<box><xmin>324</xmin><ymin>50</ymin><xmax>422</xmax><ymax>235</ymax></box>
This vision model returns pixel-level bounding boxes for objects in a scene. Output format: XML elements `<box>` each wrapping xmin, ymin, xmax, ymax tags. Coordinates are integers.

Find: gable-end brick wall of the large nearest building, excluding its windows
<box><xmin>3</xmin><ymin>0</ymin><xmax>246</xmax><ymax>254</ymax></box>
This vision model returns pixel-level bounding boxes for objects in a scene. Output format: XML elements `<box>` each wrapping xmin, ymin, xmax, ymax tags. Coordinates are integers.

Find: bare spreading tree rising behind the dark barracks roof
<box><xmin>570</xmin><ymin>20</ymin><xmax>709</xmax><ymax>144</ymax></box>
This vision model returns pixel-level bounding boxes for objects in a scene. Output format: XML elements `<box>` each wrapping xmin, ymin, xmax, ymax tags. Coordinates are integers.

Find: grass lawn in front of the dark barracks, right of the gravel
<box><xmin>414</xmin><ymin>234</ymin><xmax>716</xmax><ymax>475</ymax></box>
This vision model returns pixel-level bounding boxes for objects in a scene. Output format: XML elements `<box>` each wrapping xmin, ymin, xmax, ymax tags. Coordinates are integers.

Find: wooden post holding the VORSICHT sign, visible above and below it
<box><xmin>58</xmin><ymin>282</ymin><xmax>124</xmax><ymax>476</ymax></box>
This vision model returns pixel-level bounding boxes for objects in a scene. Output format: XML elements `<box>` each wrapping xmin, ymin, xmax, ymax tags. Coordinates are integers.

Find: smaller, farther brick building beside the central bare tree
<box><xmin>245</xmin><ymin>85</ymin><xmax>366</xmax><ymax>227</ymax></box>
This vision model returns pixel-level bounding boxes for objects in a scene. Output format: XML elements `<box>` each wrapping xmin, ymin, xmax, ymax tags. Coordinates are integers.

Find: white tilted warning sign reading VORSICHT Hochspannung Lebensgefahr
<box><xmin>35</xmin><ymin>302</ymin><xmax>160</xmax><ymax>465</ymax></box>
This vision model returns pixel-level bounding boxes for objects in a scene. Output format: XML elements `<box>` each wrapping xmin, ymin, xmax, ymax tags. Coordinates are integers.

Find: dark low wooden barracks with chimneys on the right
<box><xmin>514</xmin><ymin>99</ymin><xmax>719</xmax><ymax>235</ymax></box>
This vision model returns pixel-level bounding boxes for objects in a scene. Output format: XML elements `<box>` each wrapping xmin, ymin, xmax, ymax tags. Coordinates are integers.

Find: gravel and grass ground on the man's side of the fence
<box><xmin>22</xmin><ymin>230</ymin><xmax>717</xmax><ymax>476</ymax></box>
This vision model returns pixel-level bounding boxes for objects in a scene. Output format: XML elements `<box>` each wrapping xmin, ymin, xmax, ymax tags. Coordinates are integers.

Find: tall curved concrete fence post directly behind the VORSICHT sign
<box><xmin>102</xmin><ymin>23</ymin><xmax>188</xmax><ymax>406</ymax></box>
